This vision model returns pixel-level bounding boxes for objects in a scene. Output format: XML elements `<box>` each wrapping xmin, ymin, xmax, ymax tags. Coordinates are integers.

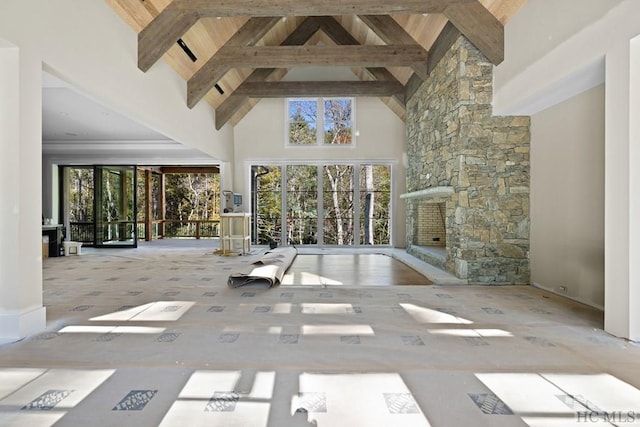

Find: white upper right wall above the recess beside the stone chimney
<box><xmin>493</xmin><ymin>0</ymin><xmax>640</xmax><ymax>115</ymax></box>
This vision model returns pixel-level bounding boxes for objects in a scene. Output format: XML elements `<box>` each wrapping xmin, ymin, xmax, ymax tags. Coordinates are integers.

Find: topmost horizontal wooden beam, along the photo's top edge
<box><xmin>171</xmin><ymin>0</ymin><xmax>473</xmax><ymax>16</ymax></box>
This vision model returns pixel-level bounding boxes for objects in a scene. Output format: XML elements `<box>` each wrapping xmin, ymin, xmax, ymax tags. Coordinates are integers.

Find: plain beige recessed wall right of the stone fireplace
<box><xmin>531</xmin><ymin>86</ymin><xmax>605</xmax><ymax>308</ymax></box>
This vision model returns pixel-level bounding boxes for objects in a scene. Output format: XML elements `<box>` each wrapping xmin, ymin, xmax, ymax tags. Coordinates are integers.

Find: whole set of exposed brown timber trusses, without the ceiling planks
<box><xmin>138</xmin><ymin>0</ymin><xmax>504</xmax><ymax>129</ymax></box>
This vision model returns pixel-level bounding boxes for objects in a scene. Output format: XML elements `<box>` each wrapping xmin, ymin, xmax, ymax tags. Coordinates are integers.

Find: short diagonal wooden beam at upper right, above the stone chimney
<box><xmin>444</xmin><ymin>1</ymin><xmax>504</xmax><ymax>65</ymax></box>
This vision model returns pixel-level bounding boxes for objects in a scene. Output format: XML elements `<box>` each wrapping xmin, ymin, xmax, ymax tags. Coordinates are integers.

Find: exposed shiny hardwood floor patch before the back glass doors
<box><xmin>283</xmin><ymin>254</ymin><xmax>433</xmax><ymax>286</ymax></box>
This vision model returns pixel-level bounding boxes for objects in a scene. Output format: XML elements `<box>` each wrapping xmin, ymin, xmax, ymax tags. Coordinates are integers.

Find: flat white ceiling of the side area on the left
<box><xmin>42</xmin><ymin>72</ymin><xmax>212</xmax><ymax>165</ymax></box>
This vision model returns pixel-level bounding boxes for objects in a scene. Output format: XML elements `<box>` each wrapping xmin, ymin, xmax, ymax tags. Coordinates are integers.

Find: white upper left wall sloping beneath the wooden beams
<box><xmin>0</xmin><ymin>0</ymin><xmax>233</xmax><ymax>160</ymax></box>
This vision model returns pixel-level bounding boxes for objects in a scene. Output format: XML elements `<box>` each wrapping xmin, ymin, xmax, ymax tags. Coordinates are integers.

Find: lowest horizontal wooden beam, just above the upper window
<box><xmin>233</xmin><ymin>81</ymin><xmax>404</xmax><ymax>98</ymax></box>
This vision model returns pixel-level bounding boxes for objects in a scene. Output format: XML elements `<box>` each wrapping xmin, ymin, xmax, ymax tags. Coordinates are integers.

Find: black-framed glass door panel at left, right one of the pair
<box><xmin>95</xmin><ymin>166</ymin><xmax>138</xmax><ymax>247</ymax></box>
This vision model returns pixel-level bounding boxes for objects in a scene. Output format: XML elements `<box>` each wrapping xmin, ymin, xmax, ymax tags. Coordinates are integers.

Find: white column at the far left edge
<box><xmin>0</xmin><ymin>40</ymin><xmax>46</xmax><ymax>343</ymax></box>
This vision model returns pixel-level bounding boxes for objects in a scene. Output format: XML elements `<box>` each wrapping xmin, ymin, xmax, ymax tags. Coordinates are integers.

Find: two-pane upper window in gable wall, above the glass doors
<box><xmin>287</xmin><ymin>98</ymin><xmax>353</xmax><ymax>146</ymax></box>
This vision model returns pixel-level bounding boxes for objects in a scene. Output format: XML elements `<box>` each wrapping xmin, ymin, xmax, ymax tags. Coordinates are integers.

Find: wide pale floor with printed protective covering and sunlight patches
<box><xmin>0</xmin><ymin>241</ymin><xmax>640</xmax><ymax>427</ymax></box>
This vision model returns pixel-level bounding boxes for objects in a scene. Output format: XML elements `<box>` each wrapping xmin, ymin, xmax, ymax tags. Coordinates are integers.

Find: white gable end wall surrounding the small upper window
<box><xmin>233</xmin><ymin>98</ymin><xmax>406</xmax><ymax>247</ymax></box>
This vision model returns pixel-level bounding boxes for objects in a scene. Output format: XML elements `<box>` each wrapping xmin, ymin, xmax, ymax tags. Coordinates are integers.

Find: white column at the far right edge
<box><xmin>605</xmin><ymin>37</ymin><xmax>640</xmax><ymax>341</ymax></box>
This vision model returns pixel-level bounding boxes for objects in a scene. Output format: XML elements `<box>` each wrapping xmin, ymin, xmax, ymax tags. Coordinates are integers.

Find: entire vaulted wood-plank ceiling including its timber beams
<box><xmin>106</xmin><ymin>0</ymin><xmax>527</xmax><ymax>129</ymax></box>
